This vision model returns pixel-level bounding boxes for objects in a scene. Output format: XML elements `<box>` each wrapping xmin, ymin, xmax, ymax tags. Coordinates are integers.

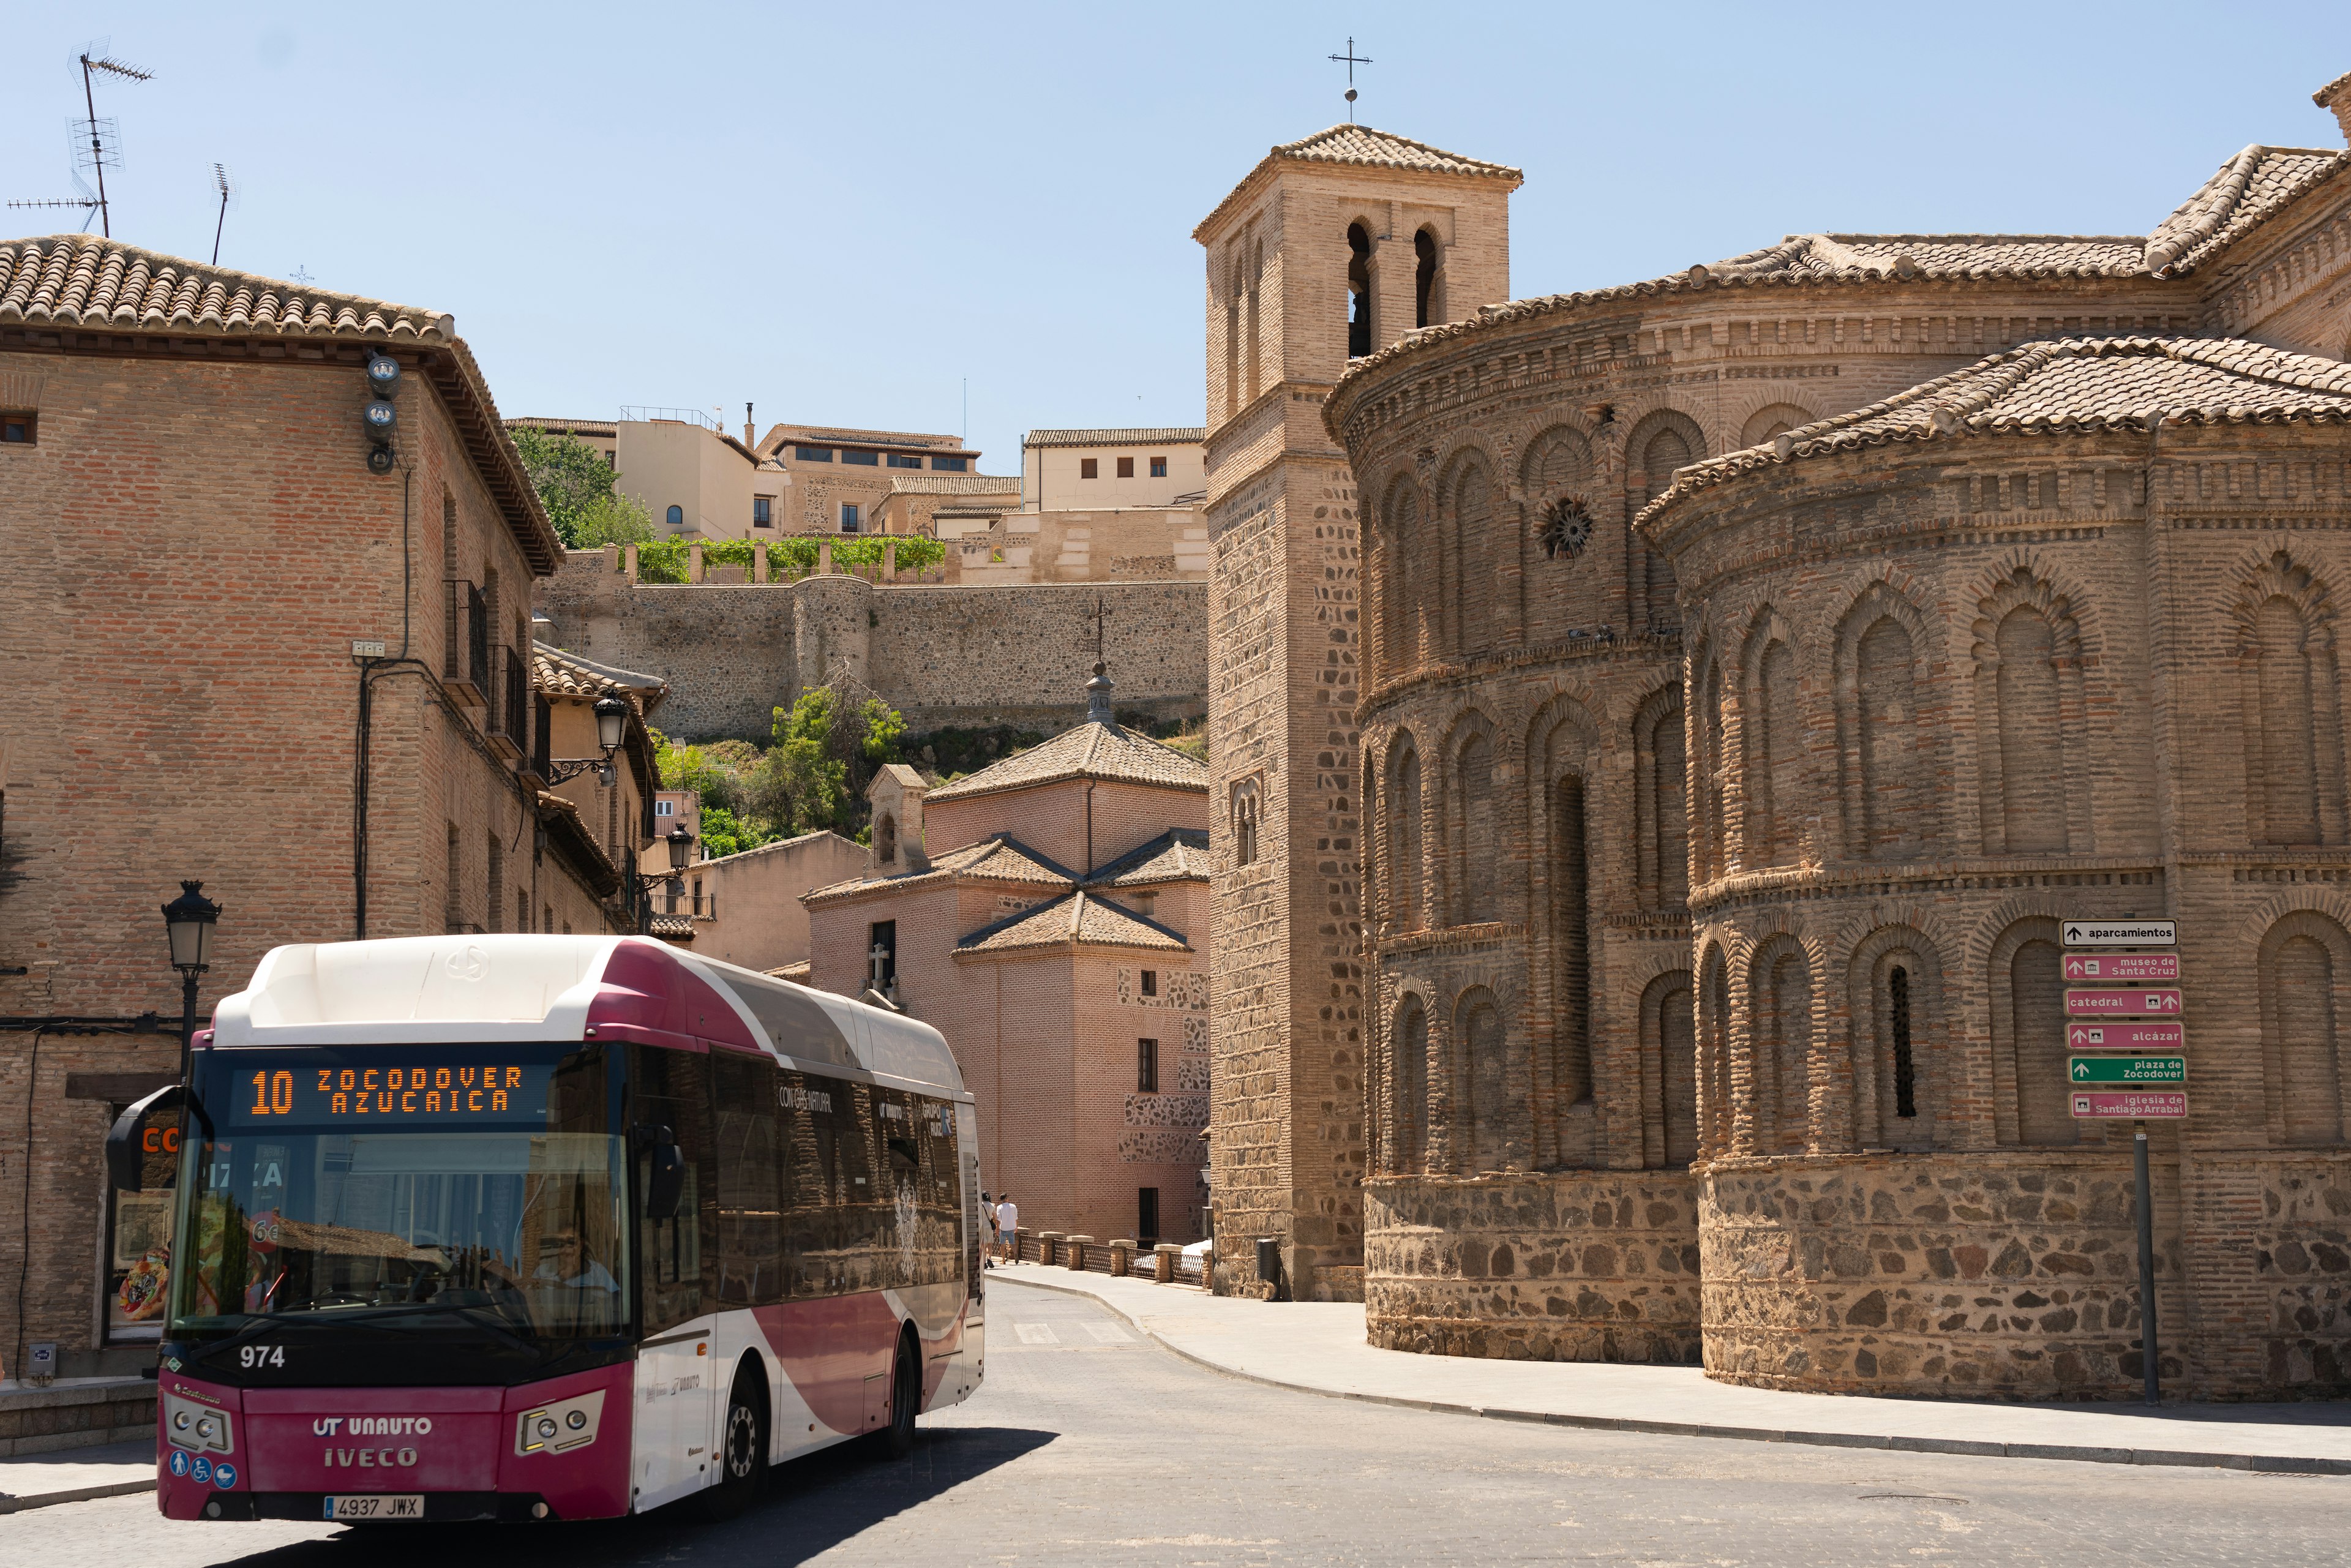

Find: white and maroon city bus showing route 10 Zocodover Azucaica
<box><xmin>108</xmin><ymin>936</ymin><xmax>983</xmax><ymax>1521</ymax></box>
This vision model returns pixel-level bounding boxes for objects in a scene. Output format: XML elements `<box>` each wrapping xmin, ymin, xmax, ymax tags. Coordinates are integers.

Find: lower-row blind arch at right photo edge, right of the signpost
<box><xmin>2259</xmin><ymin>910</ymin><xmax>2351</xmax><ymax>1147</ymax></box>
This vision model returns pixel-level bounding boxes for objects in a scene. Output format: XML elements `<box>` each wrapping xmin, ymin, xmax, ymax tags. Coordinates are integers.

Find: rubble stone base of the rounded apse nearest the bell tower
<box><xmin>1363</xmin><ymin>1171</ymin><xmax>1700</xmax><ymax>1364</ymax></box>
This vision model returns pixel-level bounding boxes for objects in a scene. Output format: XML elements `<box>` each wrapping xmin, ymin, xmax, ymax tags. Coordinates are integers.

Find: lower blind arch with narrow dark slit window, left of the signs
<box><xmin>1845</xmin><ymin>926</ymin><xmax>1956</xmax><ymax>1152</ymax></box>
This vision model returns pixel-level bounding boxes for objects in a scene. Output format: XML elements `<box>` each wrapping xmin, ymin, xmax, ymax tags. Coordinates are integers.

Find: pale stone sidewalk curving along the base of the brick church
<box><xmin>990</xmin><ymin>1262</ymin><xmax>2351</xmax><ymax>1474</ymax></box>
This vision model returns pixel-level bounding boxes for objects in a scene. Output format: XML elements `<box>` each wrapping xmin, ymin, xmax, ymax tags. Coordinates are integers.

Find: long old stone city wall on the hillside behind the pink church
<box><xmin>538</xmin><ymin>550</ymin><xmax>1209</xmax><ymax>740</ymax></box>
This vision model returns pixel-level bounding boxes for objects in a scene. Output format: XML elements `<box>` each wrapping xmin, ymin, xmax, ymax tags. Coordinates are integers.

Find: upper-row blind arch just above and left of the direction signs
<box><xmin>1973</xmin><ymin>566</ymin><xmax>2093</xmax><ymax>856</ymax></box>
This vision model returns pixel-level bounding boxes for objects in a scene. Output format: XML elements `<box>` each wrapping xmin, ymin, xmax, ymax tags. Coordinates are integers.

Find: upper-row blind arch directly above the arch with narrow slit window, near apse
<box><xmin>1831</xmin><ymin>583</ymin><xmax>1944</xmax><ymax>860</ymax></box>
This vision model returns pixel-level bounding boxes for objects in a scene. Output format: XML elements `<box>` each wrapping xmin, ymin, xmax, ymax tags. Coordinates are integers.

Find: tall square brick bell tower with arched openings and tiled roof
<box><xmin>1192</xmin><ymin>124</ymin><xmax>1521</xmax><ymax>1300</ymax></box>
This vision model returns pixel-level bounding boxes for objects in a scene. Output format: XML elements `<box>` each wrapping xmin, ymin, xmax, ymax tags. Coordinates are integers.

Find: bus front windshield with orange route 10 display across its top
<box><xmin>169</xmin><ymin>1044</ymin><xmax>630</xmax><ymax>1354</ymax></box>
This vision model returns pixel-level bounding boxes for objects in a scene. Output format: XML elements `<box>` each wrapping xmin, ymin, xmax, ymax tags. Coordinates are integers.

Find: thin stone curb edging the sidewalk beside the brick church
<box><xmin>997</xmin><ymin>1269</ymin><xmax>2351</xmax><ymax>1476</ymax></box>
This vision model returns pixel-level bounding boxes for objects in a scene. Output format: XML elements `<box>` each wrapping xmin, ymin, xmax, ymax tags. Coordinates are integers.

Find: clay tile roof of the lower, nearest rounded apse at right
<box><xmin>1634</xmin><ymin>339</ymin><xmax>2351</xmax><ymax>527</ymax></box>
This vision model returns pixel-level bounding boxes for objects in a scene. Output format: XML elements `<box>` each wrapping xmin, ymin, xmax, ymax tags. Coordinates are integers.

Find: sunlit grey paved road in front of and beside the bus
<box><xmin>0</xmin><ymin>1286</ymin><xmax>2351</xmax><ymax>1568</ymax></box>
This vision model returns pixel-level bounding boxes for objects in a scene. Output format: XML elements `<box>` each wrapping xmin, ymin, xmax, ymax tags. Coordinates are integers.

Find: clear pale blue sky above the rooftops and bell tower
<box><xmin>0</xmin><ymin>0</ymin><xmax>2351</xmax><ymax>473</ymax></box>
